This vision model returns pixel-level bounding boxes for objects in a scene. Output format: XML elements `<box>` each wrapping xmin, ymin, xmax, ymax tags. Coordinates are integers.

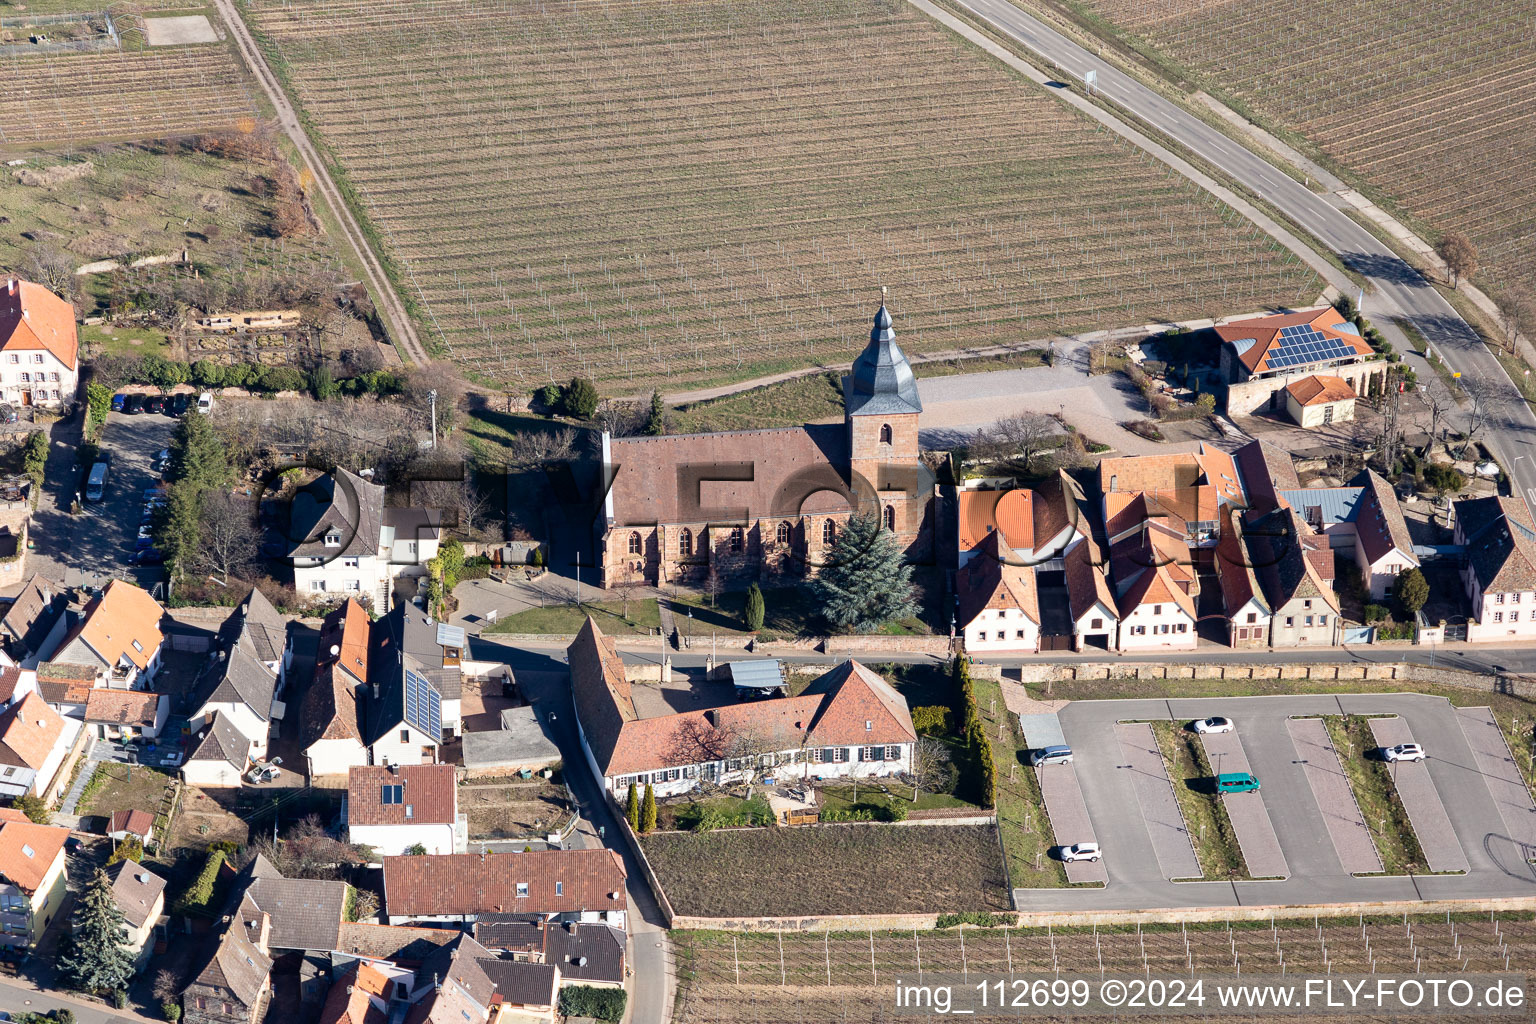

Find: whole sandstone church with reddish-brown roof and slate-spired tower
<box><xmin>598</xmin><ymin>304</ymin><xmax>935</xmax><ymax>588</ymax></box>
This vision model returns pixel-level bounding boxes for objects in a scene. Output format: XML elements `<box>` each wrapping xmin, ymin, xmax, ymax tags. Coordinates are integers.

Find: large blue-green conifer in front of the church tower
<box><xmin>813</xmin><ymin>513</ymin><xmax>917</xmax><ymax>633</ymax></box>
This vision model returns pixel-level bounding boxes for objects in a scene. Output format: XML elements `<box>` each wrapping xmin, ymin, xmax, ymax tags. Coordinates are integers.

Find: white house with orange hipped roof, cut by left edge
<box><xmin>0</xmin><ymin>278</ymin><xmax>80</xmax><ymax>408</ymax></box>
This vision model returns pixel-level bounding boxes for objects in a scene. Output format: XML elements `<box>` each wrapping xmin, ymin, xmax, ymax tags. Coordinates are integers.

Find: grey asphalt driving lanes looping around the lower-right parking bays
<box><xmin>1032</xmin><ymin>694</ymin><xmax>1536</xmax><ymax>910</ymax></box>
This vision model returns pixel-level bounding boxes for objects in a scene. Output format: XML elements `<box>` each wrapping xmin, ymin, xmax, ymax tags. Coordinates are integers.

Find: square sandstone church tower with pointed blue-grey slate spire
<box><xmin>843</xmin><ymin>289</ymin><xmax>929</xmax><ymax>539</ymax></box>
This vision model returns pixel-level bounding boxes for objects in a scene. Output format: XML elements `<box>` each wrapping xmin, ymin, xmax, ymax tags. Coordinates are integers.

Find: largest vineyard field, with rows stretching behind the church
<box><xmin>246</xmin><ymin>0</ymin><xmax>1321</xmax><ymax>395</ymax></box>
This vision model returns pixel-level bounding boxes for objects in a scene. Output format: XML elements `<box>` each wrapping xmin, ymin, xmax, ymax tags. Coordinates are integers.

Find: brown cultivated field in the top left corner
<box><xmin>0</xmin><ymin>12</ymin><xmax>257</xmax><ymax>155</ymax></box>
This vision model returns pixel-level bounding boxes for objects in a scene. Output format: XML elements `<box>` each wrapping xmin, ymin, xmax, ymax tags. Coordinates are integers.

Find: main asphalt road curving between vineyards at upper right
<box><xmin>955</xmin><ymin>0</ymin><xmax>1536</xmax><ymax>505</ymax></box>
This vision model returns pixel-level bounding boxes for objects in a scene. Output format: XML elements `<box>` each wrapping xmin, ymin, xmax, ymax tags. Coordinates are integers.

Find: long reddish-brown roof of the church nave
<box><xmin>608</xmin><ymin>424</ymin><xmax>856</xmax><ymax>527</ymax></box>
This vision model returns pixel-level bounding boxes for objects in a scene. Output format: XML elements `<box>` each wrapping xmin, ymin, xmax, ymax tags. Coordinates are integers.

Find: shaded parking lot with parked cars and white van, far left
<box><xmin>34</xmin><ymin>413</ymin><xmax>177</xmax><ymax>590</ymax></box>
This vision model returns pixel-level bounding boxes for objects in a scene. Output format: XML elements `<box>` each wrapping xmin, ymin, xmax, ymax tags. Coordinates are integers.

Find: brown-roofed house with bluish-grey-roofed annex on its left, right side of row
<box><xmin>1279</xmin><ymin>470</ymin><xmax>1419</xmax><ymax>602</ymax></box>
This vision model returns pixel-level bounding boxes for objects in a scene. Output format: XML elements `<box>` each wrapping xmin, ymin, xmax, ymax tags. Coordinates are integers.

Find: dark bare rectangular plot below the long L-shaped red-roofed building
<box><xmin>641</xmin><ymin>824</ymin><xmax>1009</xmax><ymax>917</ymax></box>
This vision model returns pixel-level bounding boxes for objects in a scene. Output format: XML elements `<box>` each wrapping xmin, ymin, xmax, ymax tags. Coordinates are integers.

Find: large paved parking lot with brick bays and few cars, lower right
<box><xmin>1014</xmin><ymin>694</ymin><xmax>1536</xmax><ymax>910</ymax></box>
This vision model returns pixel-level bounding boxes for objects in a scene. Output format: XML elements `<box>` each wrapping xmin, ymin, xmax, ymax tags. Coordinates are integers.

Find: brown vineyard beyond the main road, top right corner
<box><xmin>1061</xmin><ymin>0</ymin><xmax>1536</xmax><ymax>300</ymax></box>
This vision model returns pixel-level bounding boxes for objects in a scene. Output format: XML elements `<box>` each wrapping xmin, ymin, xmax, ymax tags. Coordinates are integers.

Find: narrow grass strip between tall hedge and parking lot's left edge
<box><xmin>971</xmin><ymin>677</ymin><xmax>1068</xmax><ymax>889</ymax></box>
